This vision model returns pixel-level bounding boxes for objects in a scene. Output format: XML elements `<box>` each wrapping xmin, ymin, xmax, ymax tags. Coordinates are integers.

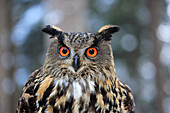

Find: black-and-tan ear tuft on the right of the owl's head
<box><xmin>97</xmin><ymin>25</ymin><xmax>120</xmax><ymax>41</ymax></box>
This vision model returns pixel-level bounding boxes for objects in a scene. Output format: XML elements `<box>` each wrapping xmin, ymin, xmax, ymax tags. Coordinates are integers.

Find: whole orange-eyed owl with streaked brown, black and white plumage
<box><xmin>16</xmin><ymin>25</ymin><xmax>135</xmax><ymax>113</ymax></box>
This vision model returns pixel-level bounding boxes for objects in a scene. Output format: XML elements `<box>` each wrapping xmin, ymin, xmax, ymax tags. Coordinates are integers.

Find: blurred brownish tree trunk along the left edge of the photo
<box><xmin>0</xmin><ymin>0</ymin><xmax>17</xmax><ymax>113</ymax></box>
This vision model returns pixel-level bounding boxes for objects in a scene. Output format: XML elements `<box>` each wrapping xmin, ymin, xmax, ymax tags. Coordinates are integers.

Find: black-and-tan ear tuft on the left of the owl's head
<box><xmin>41</xmin><ymin>25</ymin><xmax>63</xmax><ymax>38</ymax></box>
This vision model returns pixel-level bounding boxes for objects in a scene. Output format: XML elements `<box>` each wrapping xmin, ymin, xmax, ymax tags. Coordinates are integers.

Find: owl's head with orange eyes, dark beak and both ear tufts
<box><xmin>42</xmin><ymin>25</ymin><xmax>119</xmax><ymax>80</ymax></box>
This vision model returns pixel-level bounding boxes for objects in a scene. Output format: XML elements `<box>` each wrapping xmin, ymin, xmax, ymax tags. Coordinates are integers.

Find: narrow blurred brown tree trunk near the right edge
<box><xmin>148</xmin><ymin>0</ymin><xmax>164</xmax><ymax>113</ymax></box>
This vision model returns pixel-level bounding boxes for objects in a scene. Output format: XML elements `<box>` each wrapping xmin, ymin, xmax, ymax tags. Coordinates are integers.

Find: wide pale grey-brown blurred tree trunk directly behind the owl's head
<box><xmin>45</xmin><ymin>0</ymin><xmax>87</xmax><ymax>45</ymax></box>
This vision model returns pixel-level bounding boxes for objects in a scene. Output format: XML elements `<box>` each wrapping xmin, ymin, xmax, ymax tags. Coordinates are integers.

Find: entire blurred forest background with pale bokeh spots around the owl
<box><xmin>0</xmin><ymin>0</ymin><xmax>170</xmax><ymax>113</ymax></box>
